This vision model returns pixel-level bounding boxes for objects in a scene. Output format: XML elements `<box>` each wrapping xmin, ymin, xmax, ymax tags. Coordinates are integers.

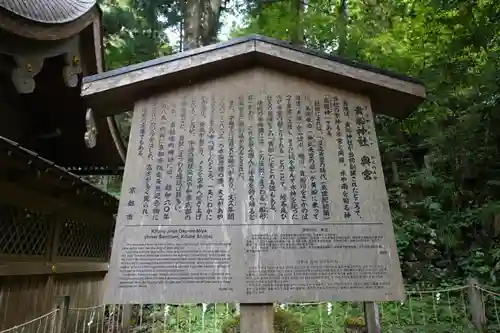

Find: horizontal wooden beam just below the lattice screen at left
<box><xmin>0</xmin><ymin>260</ymin><xmax>109</xmax><ymax>276</ymax></box>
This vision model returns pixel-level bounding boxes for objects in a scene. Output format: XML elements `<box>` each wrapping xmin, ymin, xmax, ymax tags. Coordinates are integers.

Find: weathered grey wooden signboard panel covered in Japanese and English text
<box><xmin>105</xmin><ymin>68</ymin><xmax>404</xmax><ymax>303</ymax></box>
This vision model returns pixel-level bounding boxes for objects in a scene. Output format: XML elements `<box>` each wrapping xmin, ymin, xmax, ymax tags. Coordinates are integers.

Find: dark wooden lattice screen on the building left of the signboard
<box><xmin>0</xmin><ymin>203</ymin><xmax>113</xmax><ymax>261</ymax></box>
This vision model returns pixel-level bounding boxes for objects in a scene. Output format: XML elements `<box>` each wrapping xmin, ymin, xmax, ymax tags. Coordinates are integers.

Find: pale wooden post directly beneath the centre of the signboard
<box><xmin>240</xmin><ymin>303</ymin><xmax>274</xmax><ymax>333</ymax></box>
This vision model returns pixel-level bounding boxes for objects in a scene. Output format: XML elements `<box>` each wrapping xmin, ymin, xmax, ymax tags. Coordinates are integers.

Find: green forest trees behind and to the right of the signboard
<box><xmin>94</xmin><ymin>0</ymin><xmax>500</xmax><ymax>289</ymax></box>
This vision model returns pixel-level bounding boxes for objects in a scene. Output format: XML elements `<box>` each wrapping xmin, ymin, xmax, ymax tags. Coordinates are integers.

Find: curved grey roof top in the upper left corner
<box><xmin>0</xmin><ymin>0</ymin><xmax>96</xmax><ymax>24</ymax></box>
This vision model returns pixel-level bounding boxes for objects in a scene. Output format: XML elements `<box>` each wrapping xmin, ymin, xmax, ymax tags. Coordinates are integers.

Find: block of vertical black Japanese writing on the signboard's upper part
<box><xmin>122</xmin><ymin>94</ymin><xmax>390</xmax><ymax>227</ymax></box>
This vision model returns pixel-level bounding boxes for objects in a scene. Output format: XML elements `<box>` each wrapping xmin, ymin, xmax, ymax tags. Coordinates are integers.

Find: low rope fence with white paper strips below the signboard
<box><xmin>0</xmin><ymin>281</ymin><xmax>500</xmax><ymax>333</ymax></box>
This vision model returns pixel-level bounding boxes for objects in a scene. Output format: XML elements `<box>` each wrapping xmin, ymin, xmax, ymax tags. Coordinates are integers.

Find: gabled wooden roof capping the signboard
<box><xmin>82</xmin><ymin>35</ymin><xmax>426</xmax><ymax>118</ymax></box>
